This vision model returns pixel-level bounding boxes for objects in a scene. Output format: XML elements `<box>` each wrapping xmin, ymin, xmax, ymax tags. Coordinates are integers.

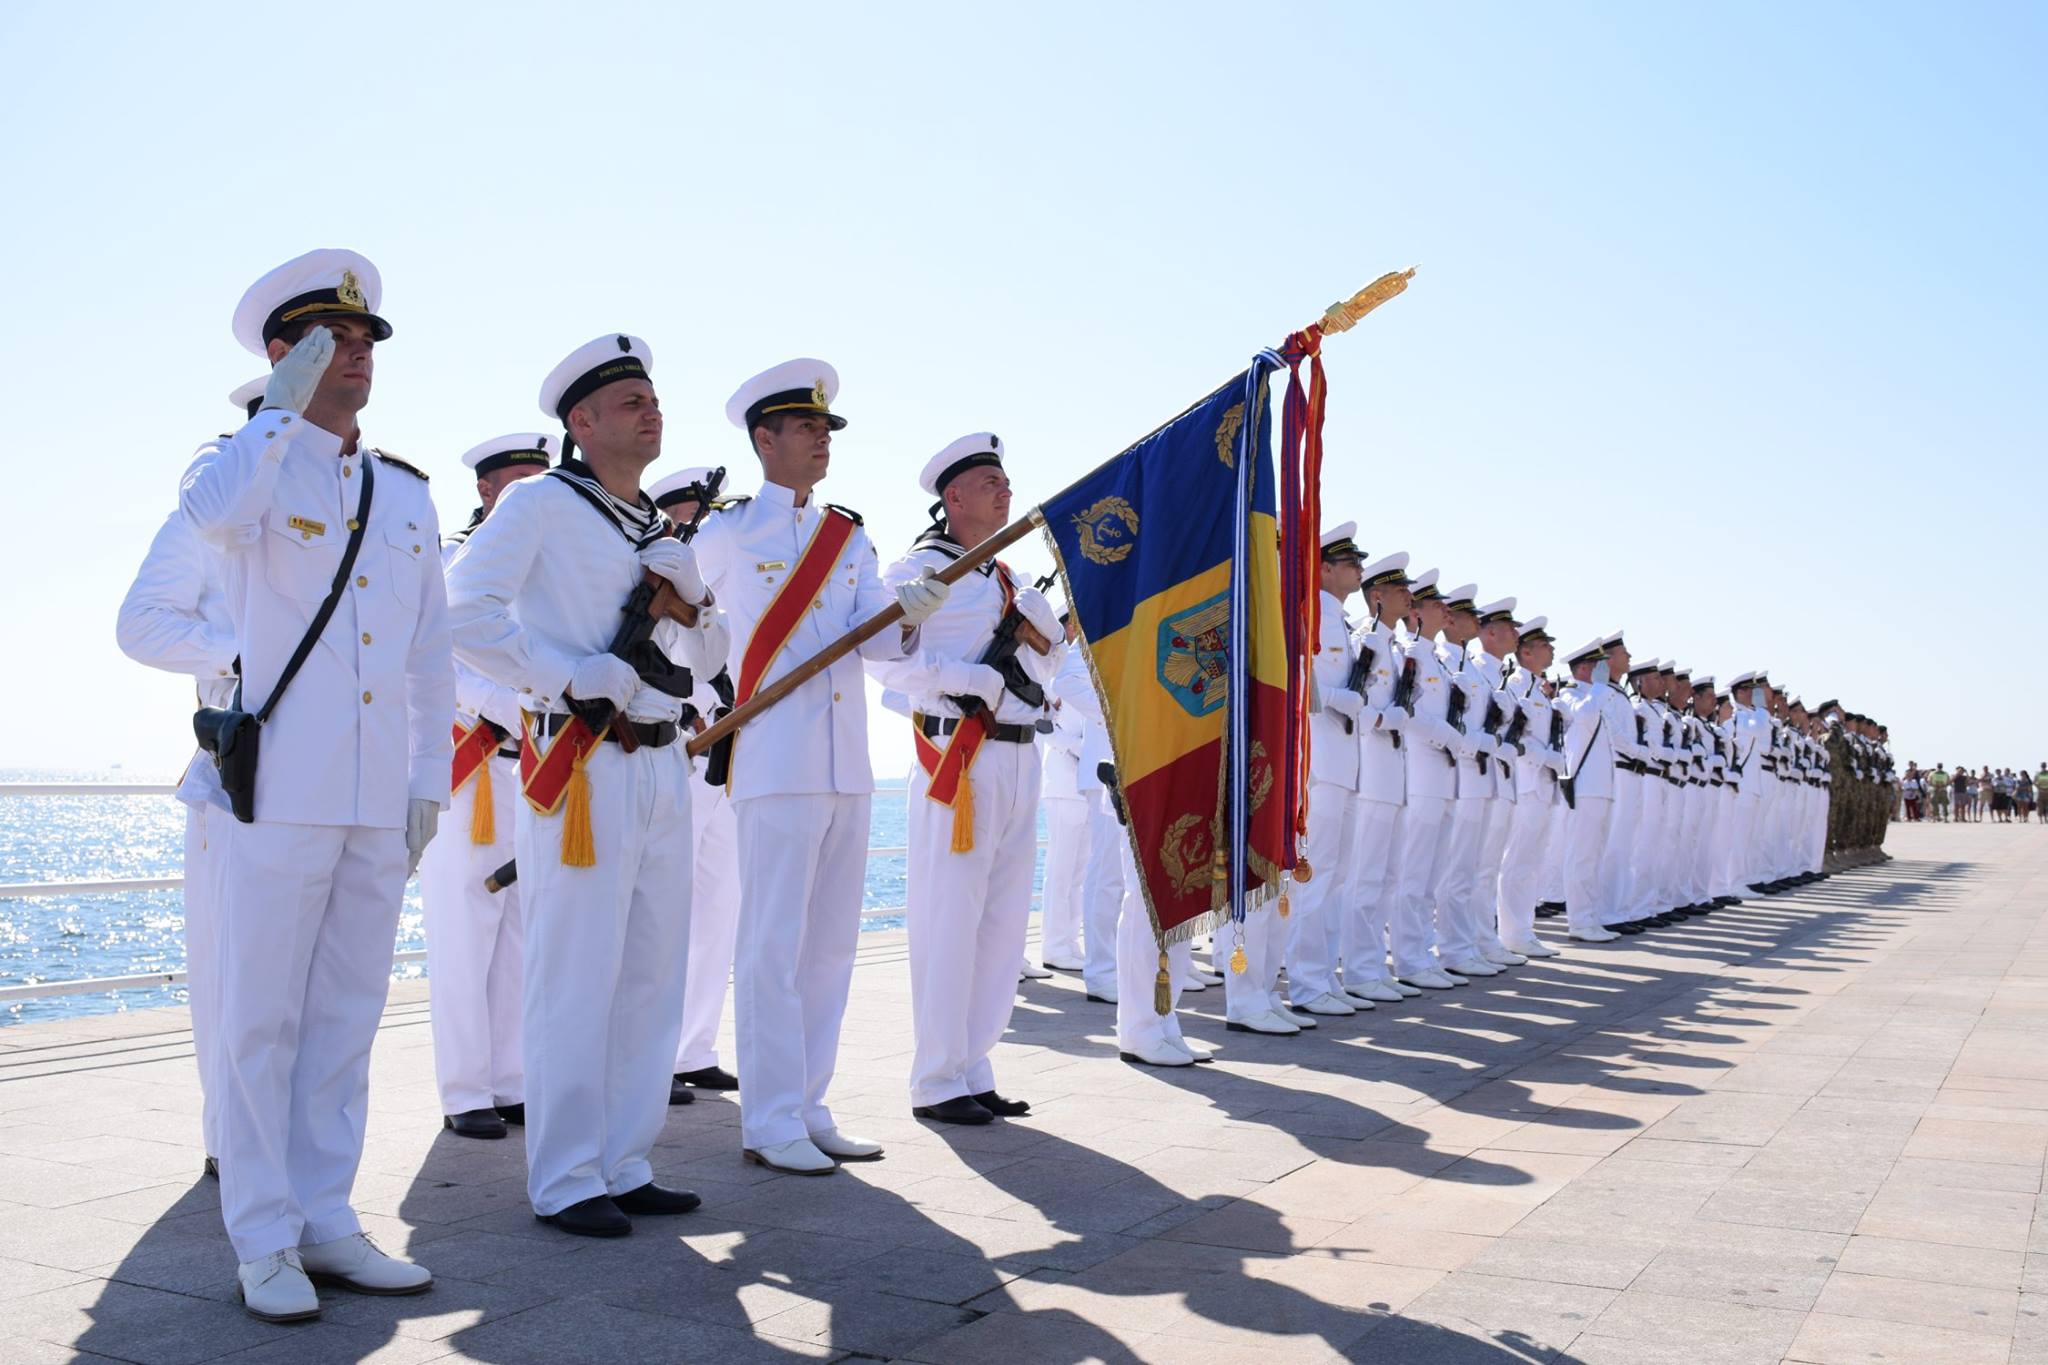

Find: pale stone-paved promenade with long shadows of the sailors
<box><xmin>0</xmin><ymin>825</ymin><xmax>2048</xmax><ymax>1365</ymax></box>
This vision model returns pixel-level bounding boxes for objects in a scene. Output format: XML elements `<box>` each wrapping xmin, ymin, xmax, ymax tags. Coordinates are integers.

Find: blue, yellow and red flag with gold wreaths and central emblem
<box><xmin>1038</xmin><ymin>362</ymin><xmax>1292</xmax><ymax>961</ymax></box>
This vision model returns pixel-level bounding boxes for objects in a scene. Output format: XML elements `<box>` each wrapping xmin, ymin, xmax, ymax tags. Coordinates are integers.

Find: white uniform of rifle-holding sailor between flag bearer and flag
<box><xmin>868</xmin><ymin>536</ymin><xmax>1061</xmax><ymax>1107</ymax></box>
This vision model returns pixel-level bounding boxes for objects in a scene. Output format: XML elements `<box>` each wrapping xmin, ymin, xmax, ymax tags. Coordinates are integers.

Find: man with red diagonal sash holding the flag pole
<box><xmin>694</xmin><ymin>360</ymin><xmax>946</xmax><ymax>1175</ymax></box>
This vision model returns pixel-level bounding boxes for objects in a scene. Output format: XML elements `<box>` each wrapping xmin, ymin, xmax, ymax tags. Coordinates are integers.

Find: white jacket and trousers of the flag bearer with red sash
<box><xmin>690</xmin><ymin>483</ymin><xmax>905</xmax><ymax>1150</ymax></box>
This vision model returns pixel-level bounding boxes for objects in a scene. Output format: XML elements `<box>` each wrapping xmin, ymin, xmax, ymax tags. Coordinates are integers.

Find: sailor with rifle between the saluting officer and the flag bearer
<box><xmin>449</xmin><ymin>334</ymin><xmax>727</xmax><ymax>1236</ymax></box>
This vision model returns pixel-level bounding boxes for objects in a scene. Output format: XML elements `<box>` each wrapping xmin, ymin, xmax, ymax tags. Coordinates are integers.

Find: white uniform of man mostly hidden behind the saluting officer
<box><xmin>115</xmin><ymin>512</ymin><xmax>236</xmax><ymax>1156</ymax></box>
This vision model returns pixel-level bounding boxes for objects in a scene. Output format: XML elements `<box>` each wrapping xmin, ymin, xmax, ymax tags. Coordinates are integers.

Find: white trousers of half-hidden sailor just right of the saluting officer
<box><xmin>420</xmin><ymin>755</ymin><xmax>526</xmax><ymax>1113</ymax></box>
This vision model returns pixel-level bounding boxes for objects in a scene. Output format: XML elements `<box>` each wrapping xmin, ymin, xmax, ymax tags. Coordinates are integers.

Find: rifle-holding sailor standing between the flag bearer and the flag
<box><xmin>868</xmin><ymin>432</ymin><xmax>1061</xmax><ymax>1124</ymax></box>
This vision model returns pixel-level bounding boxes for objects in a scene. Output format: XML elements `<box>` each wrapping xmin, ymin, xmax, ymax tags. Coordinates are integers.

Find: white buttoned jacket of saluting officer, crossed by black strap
<box><xmin>178</xmin><ymin>409</ymin><xmax>455</xmax><ymax>829</ymax></box>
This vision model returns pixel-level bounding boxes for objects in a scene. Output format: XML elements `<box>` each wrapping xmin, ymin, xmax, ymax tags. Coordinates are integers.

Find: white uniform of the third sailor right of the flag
<box><xmin>1386</xmin><ymin>636</ymin><xmax>1464</xmax><ymax>976</ymax></box>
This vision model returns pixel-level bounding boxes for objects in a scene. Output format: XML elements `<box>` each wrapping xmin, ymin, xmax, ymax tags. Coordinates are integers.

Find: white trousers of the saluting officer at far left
<box><xmin>207</xmin><ymin>810</ymin><xmax>406</xmax><ymax>1261</ymax></box>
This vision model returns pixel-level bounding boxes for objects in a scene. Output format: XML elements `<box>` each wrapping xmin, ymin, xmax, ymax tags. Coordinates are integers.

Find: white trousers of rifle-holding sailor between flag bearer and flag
<box><xmin>905</xmin><ymin>741</ymin><xmax>1038</xmax><ymax>1105</ymax></box>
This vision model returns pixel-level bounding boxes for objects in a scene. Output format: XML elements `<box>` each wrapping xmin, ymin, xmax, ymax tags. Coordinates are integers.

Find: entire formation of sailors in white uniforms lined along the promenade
<box><xmin>119</xmin><ymin>250</ymin><xmax>1884</xmax><ymax>1322</ymax></box>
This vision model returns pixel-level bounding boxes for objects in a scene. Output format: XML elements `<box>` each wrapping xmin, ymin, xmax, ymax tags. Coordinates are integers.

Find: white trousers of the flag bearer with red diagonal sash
<box><xmin>733</xmin><ymin>792</ymin><xmax>868</xmax><ymax>1150</ymax></box>
